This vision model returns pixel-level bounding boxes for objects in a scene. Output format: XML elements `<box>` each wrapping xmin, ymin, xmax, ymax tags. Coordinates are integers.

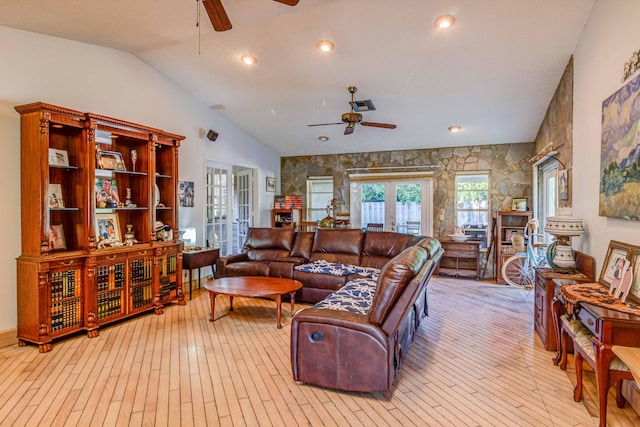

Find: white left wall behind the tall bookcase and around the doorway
<box><xmin>0</xmin><ymin>26</ymin><xmax>280</xmax><ymax>331</ymax></box>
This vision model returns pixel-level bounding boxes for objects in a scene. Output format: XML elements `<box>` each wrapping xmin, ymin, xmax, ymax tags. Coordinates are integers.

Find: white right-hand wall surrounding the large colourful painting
<box><xmin>573</xmin><ymin>0</ymin><xmax>640</xmax><ymax>274</ymax></box>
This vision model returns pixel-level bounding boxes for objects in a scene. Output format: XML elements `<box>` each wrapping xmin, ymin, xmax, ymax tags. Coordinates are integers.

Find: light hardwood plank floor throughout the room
<box><xmin>0</xmin><ymin>277</ymin><xmax>640</xmax><ymax>426</ymax></box>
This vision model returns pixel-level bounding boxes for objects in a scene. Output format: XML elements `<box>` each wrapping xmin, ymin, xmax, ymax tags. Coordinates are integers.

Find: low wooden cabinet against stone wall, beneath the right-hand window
<box><xmin>437</xmin><ymin>240</ymin><xmax>481</xmax><ymax>280</ymax></box>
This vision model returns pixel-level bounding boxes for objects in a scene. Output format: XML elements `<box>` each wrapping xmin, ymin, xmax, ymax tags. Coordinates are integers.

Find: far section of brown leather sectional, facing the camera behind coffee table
<box><xmin>215</xmin><ymin>228</ymin><xmax>441</xmax><ymax>303</ymax></box>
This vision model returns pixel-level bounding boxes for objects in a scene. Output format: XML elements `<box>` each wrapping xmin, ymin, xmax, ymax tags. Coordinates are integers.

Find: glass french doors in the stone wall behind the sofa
<box><xmin>350</xmin><ymin>179</ymin><xmax>433</xmax><ymax>236</ymax></box>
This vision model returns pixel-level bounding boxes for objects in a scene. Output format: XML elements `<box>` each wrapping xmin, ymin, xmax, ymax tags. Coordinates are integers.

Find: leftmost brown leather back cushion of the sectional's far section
<box><xmin>244</xmin><ymin>228</ymin><xmax>295</xmax><ymax>261</ymax></box>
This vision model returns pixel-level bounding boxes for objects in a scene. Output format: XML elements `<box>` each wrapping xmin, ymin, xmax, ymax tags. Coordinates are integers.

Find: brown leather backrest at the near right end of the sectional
<box><xmin>369</xmin><ymin>246</ymin><xmax>427</xmax><ymax>326</ymax></box>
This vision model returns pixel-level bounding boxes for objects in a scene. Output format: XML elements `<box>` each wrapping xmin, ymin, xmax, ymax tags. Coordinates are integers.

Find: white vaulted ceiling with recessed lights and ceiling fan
<box><xmin>0</xmin><ymin>0</ymin><xmax>593</xmax><ymax>156</ymax></box>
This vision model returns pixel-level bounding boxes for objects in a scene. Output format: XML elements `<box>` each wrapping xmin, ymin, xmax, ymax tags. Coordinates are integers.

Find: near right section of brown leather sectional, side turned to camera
<box><xmin>291</xmin><ymin>240</ymin><xmax>442</xmax><ymax>392</ymax></box>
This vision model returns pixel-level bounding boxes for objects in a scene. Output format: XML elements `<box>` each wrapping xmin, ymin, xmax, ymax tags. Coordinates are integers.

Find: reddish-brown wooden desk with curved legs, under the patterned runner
<box><xmin>554</xmin><ymin>286</ymin><xmax>640</xmax><ymax>426</ymax></box>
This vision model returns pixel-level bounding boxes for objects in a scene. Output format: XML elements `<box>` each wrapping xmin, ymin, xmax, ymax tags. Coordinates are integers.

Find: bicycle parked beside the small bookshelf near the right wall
<box><xmin>502</xmin><ymin>218</ymin><xmax>548</xmax><ymax>289</ymax></box>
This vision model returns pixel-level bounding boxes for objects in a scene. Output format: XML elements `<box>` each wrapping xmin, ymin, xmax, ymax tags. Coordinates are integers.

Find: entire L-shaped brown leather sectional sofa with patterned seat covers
<box><xmin>216</xmin><ymin>229</ymin><xmax>443</xmax><ymax>392</ymax></box>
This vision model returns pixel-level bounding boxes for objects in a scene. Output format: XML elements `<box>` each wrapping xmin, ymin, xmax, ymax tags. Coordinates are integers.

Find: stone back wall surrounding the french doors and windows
<box><xmin>280</xmin><ymin>142</ymin><xmax>534</xmax><ymax>238</ymax></box>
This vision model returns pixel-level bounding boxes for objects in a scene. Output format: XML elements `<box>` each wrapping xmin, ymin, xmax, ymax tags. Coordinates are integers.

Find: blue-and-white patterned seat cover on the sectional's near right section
<box><xmin>313</xmin><ymin>279</ymin><xmax>376</xmax><ymax>314</ymax></box>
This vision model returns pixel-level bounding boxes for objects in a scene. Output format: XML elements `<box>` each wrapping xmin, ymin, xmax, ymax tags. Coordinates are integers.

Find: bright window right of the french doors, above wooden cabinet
<box><xmin>455</xmin><ymin>172</ymin><xmax>490</xmax><ymax>248</ymax></box>
